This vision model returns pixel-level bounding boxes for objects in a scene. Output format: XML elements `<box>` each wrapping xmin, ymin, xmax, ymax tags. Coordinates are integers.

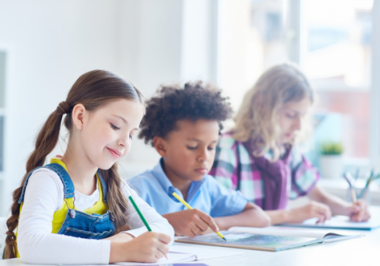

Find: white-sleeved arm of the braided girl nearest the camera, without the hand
<box><xmin>17</xmin><ymin>168</ymin><xmax>111</xmax><ymax>264</ymax></box>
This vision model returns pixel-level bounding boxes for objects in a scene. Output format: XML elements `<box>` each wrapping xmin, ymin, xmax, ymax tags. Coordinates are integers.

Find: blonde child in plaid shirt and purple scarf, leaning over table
<box><xmin>210</xmin><ymin>64</ymin><xmax>370</xmax><ymax>224</ymax></box>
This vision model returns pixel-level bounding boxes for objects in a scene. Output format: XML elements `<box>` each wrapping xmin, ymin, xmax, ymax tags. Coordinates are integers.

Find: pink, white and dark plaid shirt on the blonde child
<box><xmin>209</xmin><ymin>133</ymin><xmax>320</xmax><ymax>208</ymax></box>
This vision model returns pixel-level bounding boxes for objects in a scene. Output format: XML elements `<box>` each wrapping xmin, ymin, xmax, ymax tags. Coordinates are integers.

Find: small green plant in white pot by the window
<box><xmin>320</xmin><ymin>142</ymin><xmax>343</xmax><ymax>179</ymax></box>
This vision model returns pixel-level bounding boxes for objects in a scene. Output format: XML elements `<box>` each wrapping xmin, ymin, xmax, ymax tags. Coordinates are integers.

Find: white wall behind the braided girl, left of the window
<box><xmin>0</xmin><ymin>0</ymin><xmax>217</xmax><ymax>215</ymax></box>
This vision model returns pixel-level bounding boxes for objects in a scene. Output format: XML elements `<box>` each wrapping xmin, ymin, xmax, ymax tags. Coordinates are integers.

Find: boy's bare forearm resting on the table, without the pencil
<box><xmin>214</xmin><ymin>202</ymin><xmax>271</xmax><ymax>230</ymax></box>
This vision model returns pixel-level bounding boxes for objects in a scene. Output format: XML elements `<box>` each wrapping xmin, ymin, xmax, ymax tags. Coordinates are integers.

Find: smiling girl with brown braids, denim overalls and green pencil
<box><xmin>4</xmin><ymin>70</ymin><xmax>174</xmax><ymax>264</ymax></box>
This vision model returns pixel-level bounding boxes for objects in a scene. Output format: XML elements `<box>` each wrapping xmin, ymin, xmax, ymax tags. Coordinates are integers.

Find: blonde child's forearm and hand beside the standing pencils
<box><xmin>308</xmin><ymin>186</ymin><xmax>371</xmax><ymax>222</ymax></box>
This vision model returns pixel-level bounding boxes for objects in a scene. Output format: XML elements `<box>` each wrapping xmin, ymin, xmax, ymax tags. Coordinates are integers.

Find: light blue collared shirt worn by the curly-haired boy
<box><xmin>128</xmin><ymin>159</ymin><xmax>248</xmax><ymax>217</ymax></box>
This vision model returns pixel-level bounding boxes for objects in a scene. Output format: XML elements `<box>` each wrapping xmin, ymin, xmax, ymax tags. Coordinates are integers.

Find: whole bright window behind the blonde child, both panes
<box><xmin>217</xmin><ymin>0</ymin><xmax>373</xmax><ymax>165</ymax></box>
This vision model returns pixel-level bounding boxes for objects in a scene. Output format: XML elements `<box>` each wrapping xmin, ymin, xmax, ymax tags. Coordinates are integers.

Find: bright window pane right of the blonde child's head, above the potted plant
<box><xmin>300</xmin><ymin>0</ymin><xmax>372</xmax><ymax>159</ymax></box>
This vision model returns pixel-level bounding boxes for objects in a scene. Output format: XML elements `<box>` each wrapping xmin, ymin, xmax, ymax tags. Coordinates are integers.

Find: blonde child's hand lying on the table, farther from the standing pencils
<box><xmin>288</xmin><ymin>201</ymin><xmax>331</xmax><ymax>223</ymax></box>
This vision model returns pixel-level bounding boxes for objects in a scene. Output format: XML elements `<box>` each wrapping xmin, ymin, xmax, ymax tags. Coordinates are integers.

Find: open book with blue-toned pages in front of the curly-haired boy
<box><xmin>176</xmin><ymin>228</ymin><xmax>360</xmax><ymax>251</ymax></box>
